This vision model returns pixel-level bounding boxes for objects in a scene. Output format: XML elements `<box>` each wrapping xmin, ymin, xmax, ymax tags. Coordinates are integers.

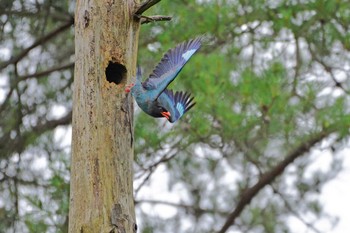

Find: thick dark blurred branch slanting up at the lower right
<box><xmin>218</xmin><ymin>128</ymin><xmax>335</xmax><ymax>233</ymax></box>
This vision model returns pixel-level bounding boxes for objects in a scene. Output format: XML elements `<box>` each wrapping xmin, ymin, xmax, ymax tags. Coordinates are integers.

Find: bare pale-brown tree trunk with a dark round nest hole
<box><xmin>68</xmin><ymin>0</ymin><xmax>140</xmax><ymax>233</ymax></box>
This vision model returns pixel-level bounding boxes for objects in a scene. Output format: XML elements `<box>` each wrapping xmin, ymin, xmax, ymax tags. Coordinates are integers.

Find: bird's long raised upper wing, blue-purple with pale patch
<box><xmin>142</xmin><ymin>37</ymin><xmax>202</xmax><ymax>95</ymax></box>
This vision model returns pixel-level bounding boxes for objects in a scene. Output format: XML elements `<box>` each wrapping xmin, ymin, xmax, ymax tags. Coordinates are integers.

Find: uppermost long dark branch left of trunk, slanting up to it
<box><xmin>0</xmin><ymin>18</ymin><xmax>74</xmax><ymax>70</ymax></box>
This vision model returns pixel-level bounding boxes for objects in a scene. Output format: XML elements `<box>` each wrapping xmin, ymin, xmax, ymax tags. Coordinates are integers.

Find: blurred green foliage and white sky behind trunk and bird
<box><xmin>0</xmin><ymin>0</ymin><xmax>350</xmax><ymax>233</ymax></box>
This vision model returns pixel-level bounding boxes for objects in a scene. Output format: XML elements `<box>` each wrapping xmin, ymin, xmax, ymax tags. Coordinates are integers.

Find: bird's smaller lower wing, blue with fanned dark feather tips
<box><xmin>157</xmin><ymin>89</ymin><xmax>196</xmax><ymax>123</ymax></box>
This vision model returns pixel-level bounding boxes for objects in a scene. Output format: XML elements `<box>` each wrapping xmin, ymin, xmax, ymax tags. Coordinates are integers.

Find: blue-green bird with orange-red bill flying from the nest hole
<box><xmin>125</xmin><ymin>37</ymin><xmax>202</xmax><ymax>123</ymax></box>
